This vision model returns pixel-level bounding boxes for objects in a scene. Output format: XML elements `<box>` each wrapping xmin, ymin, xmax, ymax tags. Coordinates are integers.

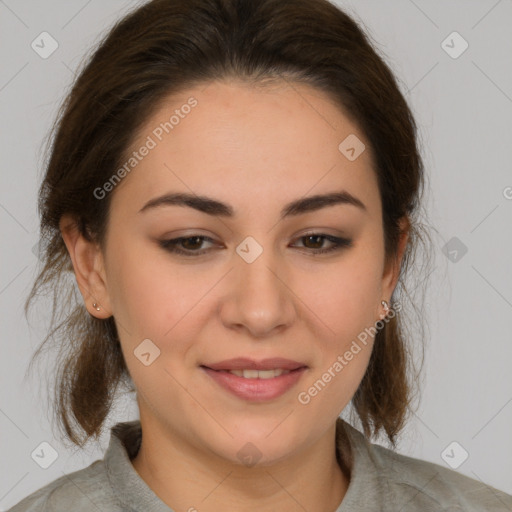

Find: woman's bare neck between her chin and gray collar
<box><xmin>132</xmin><ymin>425</ymin><xmax>349</xmax><ymax>512</ymax></box>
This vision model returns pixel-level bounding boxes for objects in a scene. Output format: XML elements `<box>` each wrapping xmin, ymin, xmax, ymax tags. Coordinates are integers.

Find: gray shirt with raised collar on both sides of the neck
<box><xmin>9</xmin><ymin>418</ymin><xmax>512</xmax><ymax>512</ymax></box>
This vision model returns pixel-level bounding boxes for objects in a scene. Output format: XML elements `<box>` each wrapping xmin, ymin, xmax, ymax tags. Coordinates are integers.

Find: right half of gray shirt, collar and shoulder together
<box><xmin>338</xmin><ymin>422</ymin><xmax>512</xmax><ymax>512</ymax></box>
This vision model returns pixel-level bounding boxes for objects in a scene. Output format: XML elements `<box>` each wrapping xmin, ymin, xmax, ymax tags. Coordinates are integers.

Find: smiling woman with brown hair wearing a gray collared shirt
<box><xmin>11</xmin><ymin>0</ymin><xmax>512</xmax><ymax>512</ymax></box>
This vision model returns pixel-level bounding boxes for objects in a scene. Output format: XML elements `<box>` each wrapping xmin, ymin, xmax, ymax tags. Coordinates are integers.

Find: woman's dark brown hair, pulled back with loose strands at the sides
<box><xmin>25</xmin><ymin>0</ymin><xmax>432</xmax><ymax>446</ymax></box>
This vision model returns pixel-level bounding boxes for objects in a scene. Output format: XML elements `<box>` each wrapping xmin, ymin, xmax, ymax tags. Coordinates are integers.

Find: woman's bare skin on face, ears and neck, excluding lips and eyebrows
<box><xmin>61</xmin><ymin>80</ymin><xmax>407</xmax><ymax>512</ymax></box>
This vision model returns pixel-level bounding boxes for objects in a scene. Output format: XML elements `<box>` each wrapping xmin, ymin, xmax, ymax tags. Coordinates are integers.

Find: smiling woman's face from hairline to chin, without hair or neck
<box><xmin>71</xmin><ymin>82</ymin><xmax>404</xmax><ymax>463</ymax></box>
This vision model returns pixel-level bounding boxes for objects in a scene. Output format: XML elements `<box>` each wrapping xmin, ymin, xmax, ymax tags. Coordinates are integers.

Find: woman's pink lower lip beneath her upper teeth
<box><xmin>201</xmin><ymin>366</ymin><xmax>307</xmax><ymax>402</ymax></box>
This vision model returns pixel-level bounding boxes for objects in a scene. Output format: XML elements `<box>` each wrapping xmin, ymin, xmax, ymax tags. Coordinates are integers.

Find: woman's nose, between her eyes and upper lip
<box><xmin>220</xmin><ymin>246</ymin><xmax>298</xmax><ymax>338</ymax></box>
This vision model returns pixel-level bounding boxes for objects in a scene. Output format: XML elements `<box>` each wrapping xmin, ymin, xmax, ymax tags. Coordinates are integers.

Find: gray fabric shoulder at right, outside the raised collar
<box><xmin>369</xmin><ymin>436</ymin><xmax>512</xmax><ymax>512</ymax></box>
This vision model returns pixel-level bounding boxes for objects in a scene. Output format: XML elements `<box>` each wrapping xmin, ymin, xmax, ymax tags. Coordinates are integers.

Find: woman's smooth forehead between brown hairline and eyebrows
<box><xmin>109</xmin><ymin>81</ymin><xmax>379</xmax><ymax>219</ymax></box>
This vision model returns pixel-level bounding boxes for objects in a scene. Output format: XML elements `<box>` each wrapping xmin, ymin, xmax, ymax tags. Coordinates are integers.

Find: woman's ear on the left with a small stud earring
<box><xmin>59</xmin><ymin>215</ymin><xmax>112</xmax><ymax>319</ymax></box>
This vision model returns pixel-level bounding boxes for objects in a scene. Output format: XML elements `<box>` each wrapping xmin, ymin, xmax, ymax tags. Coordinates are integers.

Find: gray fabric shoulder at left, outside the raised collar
<box><xmin>8</xmin><ymin>460</ymin><xmax>121</xmax><ymax>512</ymax></box>
